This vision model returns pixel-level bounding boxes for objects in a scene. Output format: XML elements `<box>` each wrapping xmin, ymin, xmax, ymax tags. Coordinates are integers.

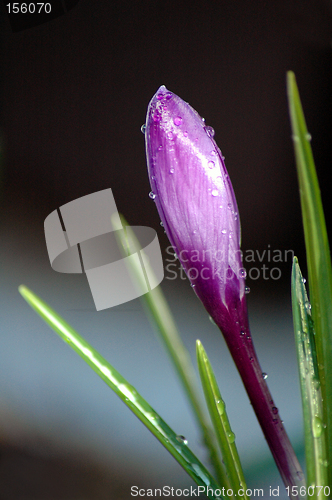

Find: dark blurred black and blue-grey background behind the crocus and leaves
<box><xmin>0</xmin><ymin>0</ymin><xmax>332</xmax><ymax>500</ymax></box>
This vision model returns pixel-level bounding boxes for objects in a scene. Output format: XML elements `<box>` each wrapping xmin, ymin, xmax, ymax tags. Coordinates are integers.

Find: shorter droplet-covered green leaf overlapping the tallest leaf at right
<box><xmin>292</xmin><ymin>257</ymin><xmax>328</xmax><ymax>500</ymax></box>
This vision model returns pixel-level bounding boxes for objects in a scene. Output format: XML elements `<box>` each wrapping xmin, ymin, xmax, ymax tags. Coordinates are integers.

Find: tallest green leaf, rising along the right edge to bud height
<box><xmin>287</xmin><ymin>71</ymin><xmax>332</xmax><ymax>488</ymax></box>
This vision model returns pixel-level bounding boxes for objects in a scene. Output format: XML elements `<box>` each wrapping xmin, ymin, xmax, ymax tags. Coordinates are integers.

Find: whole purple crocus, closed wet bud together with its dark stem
<box><xmin>145</xmin><ymin>86</ymin><xmax>303</xmax><ymax>498</ymax></box>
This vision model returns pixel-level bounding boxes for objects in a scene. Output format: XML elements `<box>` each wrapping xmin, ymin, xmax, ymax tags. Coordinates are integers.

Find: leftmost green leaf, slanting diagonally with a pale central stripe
<box><xmin>19</xmin><ymin>285</ymin><xmax>226</xmax><ymax>500</ymax></box>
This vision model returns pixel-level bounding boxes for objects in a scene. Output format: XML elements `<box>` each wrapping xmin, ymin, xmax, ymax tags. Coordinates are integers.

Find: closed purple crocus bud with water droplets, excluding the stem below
<box><xmin>145</xmin><ymin>86</ymin><xmax>247</xmax><ymax>340</ymax></box>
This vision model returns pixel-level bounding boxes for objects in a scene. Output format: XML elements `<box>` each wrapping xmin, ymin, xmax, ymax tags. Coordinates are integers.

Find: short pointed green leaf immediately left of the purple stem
<box><xmin>196</xmin><ymin>340</ymin><xmax>249</xmax><ymax>500</ymax></box>
